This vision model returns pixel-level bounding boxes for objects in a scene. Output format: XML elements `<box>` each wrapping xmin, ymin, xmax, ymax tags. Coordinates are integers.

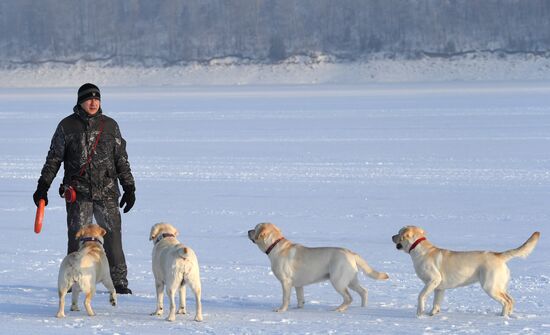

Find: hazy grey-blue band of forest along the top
<box><xmin>0</xmin><ymin>0</ymin><xmax>550</xmax><ymax>66</ymax></box>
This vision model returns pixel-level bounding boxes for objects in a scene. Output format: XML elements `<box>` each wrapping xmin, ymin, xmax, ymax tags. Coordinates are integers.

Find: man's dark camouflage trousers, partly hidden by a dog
<box><xmin>66</xmin><ymin>199</ymin><xmax>128</xmax><ymax>286</ymax></box>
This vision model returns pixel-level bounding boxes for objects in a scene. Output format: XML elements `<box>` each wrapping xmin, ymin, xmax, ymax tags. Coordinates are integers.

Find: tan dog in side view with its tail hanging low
<box><xmin>248</xmin><ymin>223</ymin><xmax>388</xmax><ymax>312</ymax></box>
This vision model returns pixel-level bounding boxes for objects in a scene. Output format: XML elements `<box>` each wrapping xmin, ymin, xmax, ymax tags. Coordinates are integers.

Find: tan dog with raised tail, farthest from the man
<box><xmin>392</xmin><ymin>226</ymin><xmax>540</xmax><ymax>316</ymax></box>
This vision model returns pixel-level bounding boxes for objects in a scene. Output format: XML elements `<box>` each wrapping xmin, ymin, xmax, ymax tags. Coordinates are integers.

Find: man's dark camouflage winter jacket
<box><xmin>38</xmin><ymin>105</ymin><xmax>135</xmax><ymax>200</ymax></box>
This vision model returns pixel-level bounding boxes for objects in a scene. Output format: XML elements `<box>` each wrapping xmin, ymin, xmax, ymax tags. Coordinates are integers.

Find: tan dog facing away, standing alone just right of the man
<box><xmin>149</xmin><ymin>223</ymin><xmax>202</xmax><ymax>321</ymax></box>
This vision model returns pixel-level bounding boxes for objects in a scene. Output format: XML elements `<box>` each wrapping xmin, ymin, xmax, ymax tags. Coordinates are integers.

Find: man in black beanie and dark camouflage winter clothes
<box><xmin>33</xmin><ymin>83</ymin><xmax>136</xmax><ymax>294</ymax></box>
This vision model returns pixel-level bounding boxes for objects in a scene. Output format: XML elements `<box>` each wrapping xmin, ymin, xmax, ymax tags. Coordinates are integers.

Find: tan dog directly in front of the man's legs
<box><xmin>57</xmin><ymin>224</ymin><xmax>116</xmax><ymax>318</ymax></box>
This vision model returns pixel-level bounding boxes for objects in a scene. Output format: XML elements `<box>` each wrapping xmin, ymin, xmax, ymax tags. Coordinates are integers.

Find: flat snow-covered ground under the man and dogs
<box><xmin>0</xmin><ymin>77</ymin><xmax>550</xmax><ymax>334</ymax></box>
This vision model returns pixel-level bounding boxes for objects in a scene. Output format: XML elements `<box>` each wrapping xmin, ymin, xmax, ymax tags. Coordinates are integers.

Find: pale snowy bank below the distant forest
<box><xmin>0</xmin><ymin>53</ymin><xmax>550</xmax><ymax>88</ymax></box>
